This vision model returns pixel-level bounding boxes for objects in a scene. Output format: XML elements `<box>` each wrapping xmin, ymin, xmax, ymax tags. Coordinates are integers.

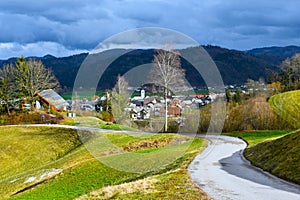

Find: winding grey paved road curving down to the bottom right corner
<box><xmin>188</xmin><ymin>136</ymin><xmax>300</xmax><ymax>200</ymax></box>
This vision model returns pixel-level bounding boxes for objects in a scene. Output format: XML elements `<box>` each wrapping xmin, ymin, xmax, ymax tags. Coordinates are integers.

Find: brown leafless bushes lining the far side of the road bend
<box><xmin>198</xmin><ymin>97</ymin><xmax>291</xmax><ymax>133</ymax></box>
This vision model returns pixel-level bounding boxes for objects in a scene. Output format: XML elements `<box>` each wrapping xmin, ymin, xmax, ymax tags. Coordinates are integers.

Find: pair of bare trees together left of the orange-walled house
<box><xmin>0</xmin><ymin>57</ymin><xmax>59</xmax><ymax>114</ymax></box>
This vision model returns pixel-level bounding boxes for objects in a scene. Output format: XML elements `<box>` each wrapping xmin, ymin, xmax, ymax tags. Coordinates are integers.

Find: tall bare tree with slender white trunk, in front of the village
<box><xmin>149</xmin><ymin>45</ymin><xmax>185</xmax><ymax>132</ymax></box>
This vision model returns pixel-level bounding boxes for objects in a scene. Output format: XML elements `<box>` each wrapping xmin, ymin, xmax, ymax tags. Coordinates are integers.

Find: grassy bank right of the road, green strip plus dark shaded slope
<box><xmin>224</xmin><ymin>131</ymin><xmax>300</xmax><ymax>184</ymax></box>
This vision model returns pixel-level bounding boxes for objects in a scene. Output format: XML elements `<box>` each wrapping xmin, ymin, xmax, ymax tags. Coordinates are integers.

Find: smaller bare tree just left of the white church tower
<box><xmin>111</xmin><ymin>75</ymin><xmax>130</xmax><ymax>124</ymax></box>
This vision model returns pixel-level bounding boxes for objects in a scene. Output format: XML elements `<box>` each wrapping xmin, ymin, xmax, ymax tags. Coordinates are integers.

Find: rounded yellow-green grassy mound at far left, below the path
<box><xmin>0</xmin><ymin>127</ymin><xmax>81</xmax><ymax>180</ymax></box>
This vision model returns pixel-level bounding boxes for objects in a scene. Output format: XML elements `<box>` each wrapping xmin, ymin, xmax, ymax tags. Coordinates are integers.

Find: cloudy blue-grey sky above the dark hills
<box><xmin>0</xmin><ymin>0</ymin><xmax>300</xmax><ymax>59</ymax></box>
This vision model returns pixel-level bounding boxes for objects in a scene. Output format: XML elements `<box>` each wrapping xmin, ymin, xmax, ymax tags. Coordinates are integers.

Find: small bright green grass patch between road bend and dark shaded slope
<box><xmin>223</xmin><ymin>130</ymin><xmax>289</xmax><ymax>147</ymax></box>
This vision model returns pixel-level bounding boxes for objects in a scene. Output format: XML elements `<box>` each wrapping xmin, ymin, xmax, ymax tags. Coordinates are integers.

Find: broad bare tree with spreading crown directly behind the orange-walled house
<box><xmin>16</xmin><ymin>57</ymin><xmax>59</xmax><ymax>108</ymax></box>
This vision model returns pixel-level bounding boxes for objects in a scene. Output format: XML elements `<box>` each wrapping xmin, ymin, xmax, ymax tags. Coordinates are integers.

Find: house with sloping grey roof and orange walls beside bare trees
<box><xmin>36</xmin><ymin>89</ymin><xmax>69</xmax><ymax>111</ymax></box>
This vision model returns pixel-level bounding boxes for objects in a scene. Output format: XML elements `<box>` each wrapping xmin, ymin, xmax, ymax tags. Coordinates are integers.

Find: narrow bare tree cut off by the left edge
<box><xmin>0</xmin><ymin>64</ymin><xmax>16</xmax><ymax>115</ymax></box>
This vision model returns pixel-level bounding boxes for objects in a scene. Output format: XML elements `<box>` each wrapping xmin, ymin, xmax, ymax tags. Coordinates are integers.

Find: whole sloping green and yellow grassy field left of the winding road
<box><xmin>0</xmin><ymin>127</ymin><xmax>207</xmax><ymax>199</ymax></box>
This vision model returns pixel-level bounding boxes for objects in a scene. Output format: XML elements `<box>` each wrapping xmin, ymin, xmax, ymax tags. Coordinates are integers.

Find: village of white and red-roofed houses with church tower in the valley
<box><xmin>28</xmin><ymin>86</ymin><xmax>218</xmax><ymax>120</ymax></box>
